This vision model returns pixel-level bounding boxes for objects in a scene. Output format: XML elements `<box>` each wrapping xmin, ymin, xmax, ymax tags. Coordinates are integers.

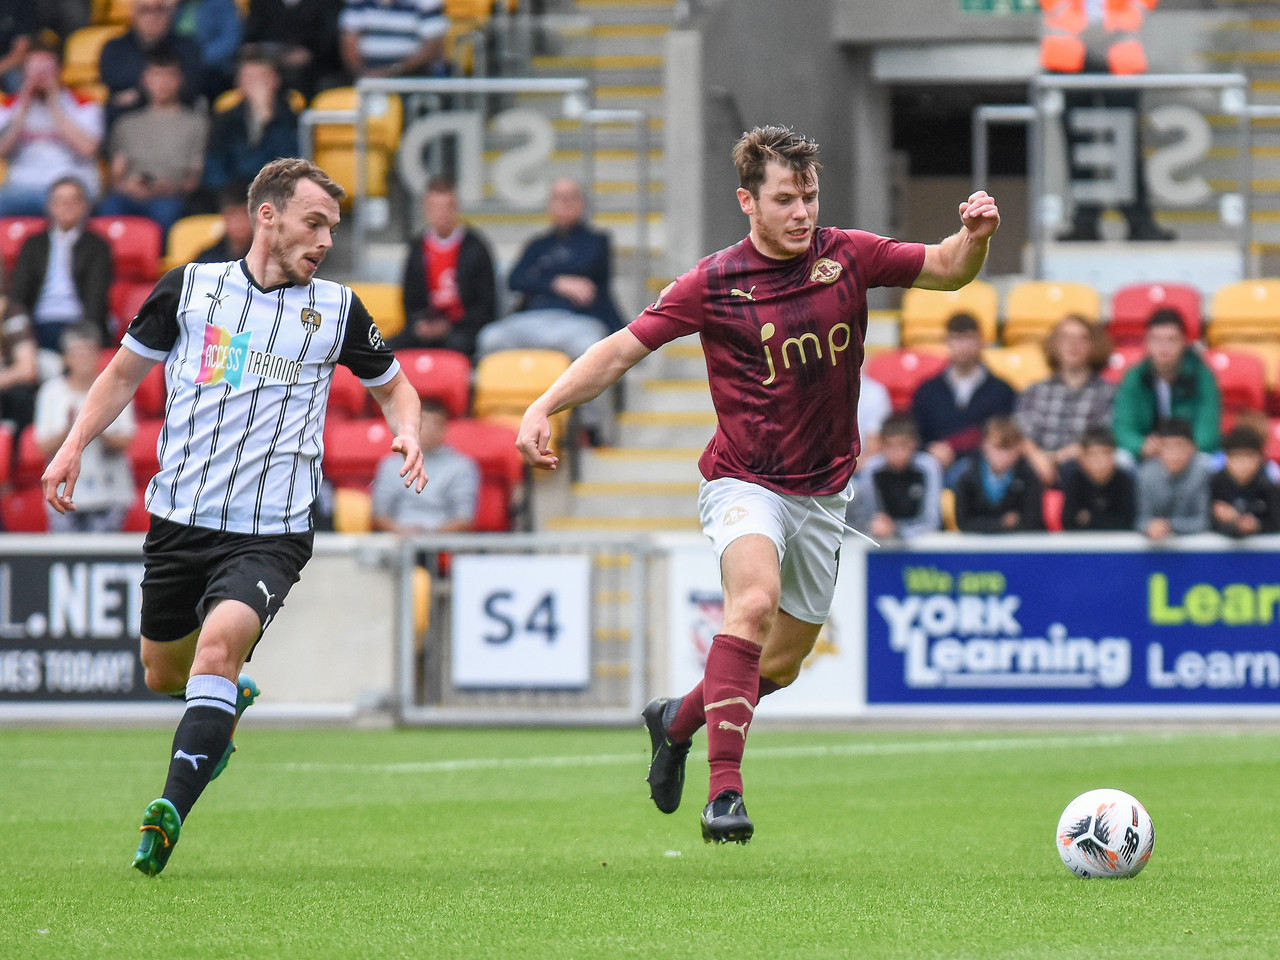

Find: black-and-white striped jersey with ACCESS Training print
<box><xmin>123</xmin><ymin>260</ymin><xmax>399</xmax><ymax>534</ymax></box>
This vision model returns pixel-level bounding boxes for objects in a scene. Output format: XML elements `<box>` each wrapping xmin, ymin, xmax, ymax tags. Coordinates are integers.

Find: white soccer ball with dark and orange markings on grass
<box><xmin>1057</xmin><ymin>788</ymin><xmax>1156</xmax><ymax>879</ymax></box>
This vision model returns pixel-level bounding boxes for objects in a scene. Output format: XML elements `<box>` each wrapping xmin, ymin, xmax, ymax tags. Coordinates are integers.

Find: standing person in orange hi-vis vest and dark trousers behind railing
<box><xmin>1041</xmin><ymin>0</ymin><xmax>1174</xmax><ymax>241</ymax></box>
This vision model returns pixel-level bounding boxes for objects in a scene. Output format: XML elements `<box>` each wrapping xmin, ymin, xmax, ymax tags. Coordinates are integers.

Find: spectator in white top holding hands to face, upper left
<box><xmin>0</xmin><ymin>45</ymin><xmax>102</xmax><ymax>216</ymax></box>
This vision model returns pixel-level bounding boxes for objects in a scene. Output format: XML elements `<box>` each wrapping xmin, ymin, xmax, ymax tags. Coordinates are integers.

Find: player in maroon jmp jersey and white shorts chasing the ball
<box><xmin>517</xmin><ymin>127</ymin><xmax>1000</xmax><ymax>844</ymax></box>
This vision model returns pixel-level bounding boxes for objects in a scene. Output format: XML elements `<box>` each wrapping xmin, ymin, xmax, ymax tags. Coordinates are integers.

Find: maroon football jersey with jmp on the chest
<box><xmin>628</xmin><ymin>227</ymin><xmax>924</xmax><ymax>495</ymax></box>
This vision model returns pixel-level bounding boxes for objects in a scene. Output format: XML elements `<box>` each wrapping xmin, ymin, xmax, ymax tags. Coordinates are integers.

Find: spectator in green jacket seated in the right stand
<box><xmin>1111</xmin><ymin>310</ymin><xmax>1222</xmax><ymax>461</ymax></box>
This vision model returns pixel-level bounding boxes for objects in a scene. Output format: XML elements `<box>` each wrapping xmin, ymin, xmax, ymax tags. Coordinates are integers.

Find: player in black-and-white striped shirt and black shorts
<box><xmin>42</xmin><ymin>159</ymin><xmax>426</xmax><ymax>876</ymax></box>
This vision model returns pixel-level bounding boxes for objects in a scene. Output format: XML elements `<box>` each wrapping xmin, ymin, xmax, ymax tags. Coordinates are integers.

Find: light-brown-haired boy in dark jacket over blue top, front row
<box><xmin>955</xmin><ymin>416</ymin><xmax>1044</xmax><ymax>534</ymax></box>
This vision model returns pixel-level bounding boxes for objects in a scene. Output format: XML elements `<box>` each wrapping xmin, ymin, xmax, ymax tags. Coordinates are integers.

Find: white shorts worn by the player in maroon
<box><xmin>698</xmin><ymin>477</ymin><xmax>852</xmax><ymax>623</ymax></box>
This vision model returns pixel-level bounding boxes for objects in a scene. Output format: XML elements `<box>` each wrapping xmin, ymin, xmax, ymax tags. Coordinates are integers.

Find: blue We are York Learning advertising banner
<box><xmin>867</xmin><ymin>550</ymin><xmax>1280</xmax><ymax>704</ymax></box>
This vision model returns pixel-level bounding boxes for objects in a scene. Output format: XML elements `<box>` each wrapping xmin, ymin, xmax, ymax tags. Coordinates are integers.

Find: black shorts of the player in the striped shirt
<box><xmin>142</xmin><ymin>516</ymin><xmax>315</xmax><ymax>643</ymax></box>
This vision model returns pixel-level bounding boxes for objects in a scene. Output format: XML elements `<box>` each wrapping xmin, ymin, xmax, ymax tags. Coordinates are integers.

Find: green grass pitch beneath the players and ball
<box><xmin>0</xmin><ymin>717</ymin><xmax>1280</xmax><ymax>960</ymax></box>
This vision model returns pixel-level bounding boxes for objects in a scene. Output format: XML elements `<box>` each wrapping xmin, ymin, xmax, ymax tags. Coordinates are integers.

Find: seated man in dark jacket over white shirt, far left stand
<box><xmin>9</xmin><ymin>177</ymin><xmax>113</xmax><ymax>358</ymax></box>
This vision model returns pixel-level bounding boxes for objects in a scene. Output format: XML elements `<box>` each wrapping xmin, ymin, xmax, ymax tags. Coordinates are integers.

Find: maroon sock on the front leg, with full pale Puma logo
<box><xmin>703</xmin><ymin>634</ymin><xmax>760</xmax><ymax>800</ymax></box>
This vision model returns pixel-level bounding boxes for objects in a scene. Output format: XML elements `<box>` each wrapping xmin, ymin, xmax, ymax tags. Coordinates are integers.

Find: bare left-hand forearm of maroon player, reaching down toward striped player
<box><xmin>516</xmin><ymin>328</ymin><xmax>650</xmax><ymax>470</ymax></box>
